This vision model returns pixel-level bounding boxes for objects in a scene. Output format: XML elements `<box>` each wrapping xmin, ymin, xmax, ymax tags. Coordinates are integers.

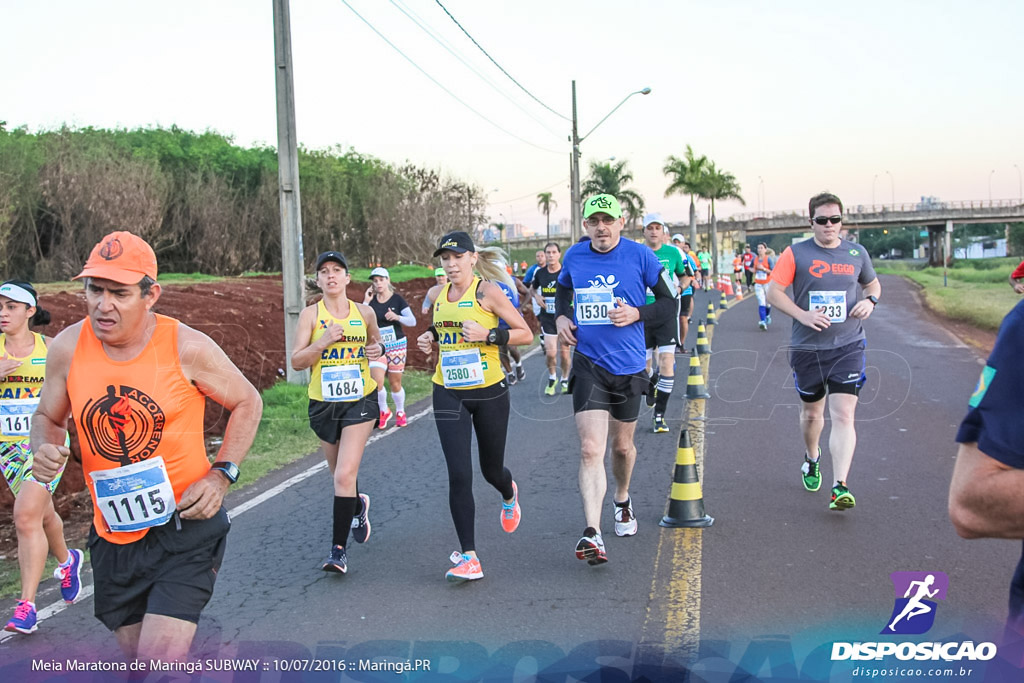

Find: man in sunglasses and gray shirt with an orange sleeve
<box><xmin>767</xmin><ymin>193</ymin><xmax>882</xmax><ymax>510</ymax></box>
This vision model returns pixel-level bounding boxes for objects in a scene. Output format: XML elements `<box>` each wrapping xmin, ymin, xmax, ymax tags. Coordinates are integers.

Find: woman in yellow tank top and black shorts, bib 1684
<box><xmin>292</xmin><ymin>251</ymin><xmax>384</xmax><ymax>573</ymax></box>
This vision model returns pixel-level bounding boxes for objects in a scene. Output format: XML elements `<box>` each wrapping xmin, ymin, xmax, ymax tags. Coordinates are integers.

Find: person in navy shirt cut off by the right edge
<box><xmin>949</xmin><ymin>301</ymin><xmax>1024</xmax><ymax>647</ymax></box>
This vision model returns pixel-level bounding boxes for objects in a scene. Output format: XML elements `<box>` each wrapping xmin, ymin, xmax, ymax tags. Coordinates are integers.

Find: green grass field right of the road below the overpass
<box><xmin>876</xmin><ymin>258</ymin><xmax>1020</xmax><ymax>332</ymax></box>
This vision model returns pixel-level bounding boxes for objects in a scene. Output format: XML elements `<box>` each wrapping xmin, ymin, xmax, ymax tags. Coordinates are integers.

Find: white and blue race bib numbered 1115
<box><xmin>89</xmin><ymin>456</ymin><xmax>175</xmax><ymax>531</ymax></box>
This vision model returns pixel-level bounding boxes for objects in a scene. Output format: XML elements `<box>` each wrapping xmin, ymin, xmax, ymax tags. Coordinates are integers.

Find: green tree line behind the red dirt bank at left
<box><xmin>0</xmin><ymin>122</ymin><xmax>485</xmax><ymax>282</ymax></box>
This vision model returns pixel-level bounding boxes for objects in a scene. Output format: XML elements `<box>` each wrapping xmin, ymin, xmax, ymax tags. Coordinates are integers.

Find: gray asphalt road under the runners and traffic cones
<box><xmin>0</xmin><ymin>279</ymin><xmax>1019</xmax><ymax>681</ymax></box>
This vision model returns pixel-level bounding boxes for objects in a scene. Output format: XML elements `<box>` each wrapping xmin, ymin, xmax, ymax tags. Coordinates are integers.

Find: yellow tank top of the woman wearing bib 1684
<box><xmin>307</xmin><ymin>299</ymin><xmax>377</xmax><ymax>402</ymax></box>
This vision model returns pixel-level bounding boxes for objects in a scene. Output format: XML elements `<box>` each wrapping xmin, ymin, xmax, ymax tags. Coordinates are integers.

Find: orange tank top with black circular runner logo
<box><xmin>68</xmin><ymin>314</ymin><xmax>210</xmax><ymax>545</ymax></box>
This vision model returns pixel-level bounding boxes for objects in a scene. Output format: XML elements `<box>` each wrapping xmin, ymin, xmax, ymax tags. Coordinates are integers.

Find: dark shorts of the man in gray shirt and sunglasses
<box><xmin>790</xmin><ymin>339</ymin><xmax>866</xmax><ymax>403</ymax></box>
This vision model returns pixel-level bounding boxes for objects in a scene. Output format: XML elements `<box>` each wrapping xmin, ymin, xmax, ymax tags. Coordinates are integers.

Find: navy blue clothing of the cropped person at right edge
<box><xmin>956</xmin><ymin>301</ymin><xmax>1024</xmax><ymax>629</ymax></box>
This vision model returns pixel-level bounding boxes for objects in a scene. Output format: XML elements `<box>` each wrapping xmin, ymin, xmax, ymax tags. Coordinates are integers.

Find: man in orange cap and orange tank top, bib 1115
<box><xmin>31</xmin><ymin>231</ymin><xmax>263</xmax><ymax>661</ymax></box>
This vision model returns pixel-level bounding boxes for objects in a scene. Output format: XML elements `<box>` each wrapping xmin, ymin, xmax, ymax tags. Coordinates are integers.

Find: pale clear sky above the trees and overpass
<box><xmin>0</xmin><ymin>0</ymin><xmax>1024</xmax><ymax>231</ymax></box>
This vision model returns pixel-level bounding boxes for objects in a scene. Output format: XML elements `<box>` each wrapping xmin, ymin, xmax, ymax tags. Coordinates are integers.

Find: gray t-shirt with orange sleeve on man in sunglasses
<box><xmin>771</xmin><ymin>238</ymin><xmax>877</xmax><ymax>350</ymax></box>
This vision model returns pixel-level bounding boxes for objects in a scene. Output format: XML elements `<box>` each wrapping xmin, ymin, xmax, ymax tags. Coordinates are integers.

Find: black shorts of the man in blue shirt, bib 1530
<box><xmin>569</xmin><ymin>351</ymin><xmax>650</xmax><ymax>422</ymax></box>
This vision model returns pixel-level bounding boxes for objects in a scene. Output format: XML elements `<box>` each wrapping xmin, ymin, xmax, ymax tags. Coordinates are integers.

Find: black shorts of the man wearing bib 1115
<box><xmin>88</xmin><ymin>507</ymin><xmax>231</xmax><ymax>631</ymax></box>
